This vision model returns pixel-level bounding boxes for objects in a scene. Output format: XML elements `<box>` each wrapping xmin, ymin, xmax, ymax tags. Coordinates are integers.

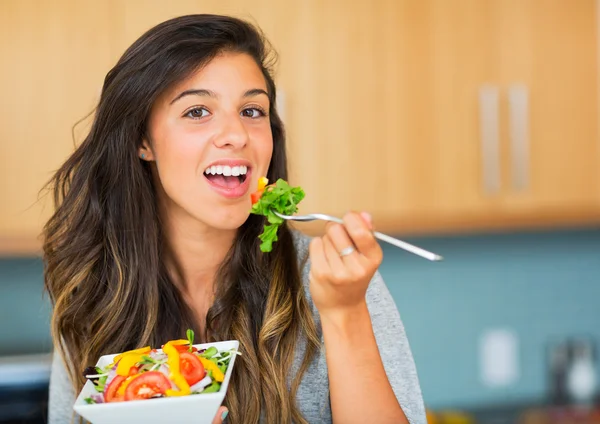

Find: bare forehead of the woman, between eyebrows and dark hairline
<box><xmin>166</xmin><ymin>52</ymin><xmax>267</xmax><ymax>98</ymax></box>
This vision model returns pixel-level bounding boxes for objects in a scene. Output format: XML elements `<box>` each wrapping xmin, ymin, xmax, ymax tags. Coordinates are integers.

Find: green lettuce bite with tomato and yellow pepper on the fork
<box><xmin>250</xmin><ymin>177</ymin><xmax>305</xmax><ymax>252</ymax></box>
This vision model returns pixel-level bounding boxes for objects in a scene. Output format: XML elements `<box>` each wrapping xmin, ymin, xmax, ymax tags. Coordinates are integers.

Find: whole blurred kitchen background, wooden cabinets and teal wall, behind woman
<box><xmin>0</xmin><ymin>0</ymin><xmax>600</xmax><ymax>424</ymax></box>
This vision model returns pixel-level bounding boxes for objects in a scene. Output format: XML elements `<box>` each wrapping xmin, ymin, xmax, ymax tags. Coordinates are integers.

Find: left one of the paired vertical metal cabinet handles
<box><xmin>479</xmin><ymin>85</ymin><xmax>500</xmax><ymax>193</ymax></box>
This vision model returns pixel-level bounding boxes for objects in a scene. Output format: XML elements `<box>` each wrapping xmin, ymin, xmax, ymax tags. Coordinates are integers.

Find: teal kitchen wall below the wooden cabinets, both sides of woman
<box><xmin>0</xmin><ymin>230</ymin><xmax>600</xmax><ymax>407</ymax></box>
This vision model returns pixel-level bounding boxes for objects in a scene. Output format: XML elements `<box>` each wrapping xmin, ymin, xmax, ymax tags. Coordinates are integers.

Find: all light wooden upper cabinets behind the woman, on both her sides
<box><xmin>0</xmin><ymin>0</ymin><xmax>600</xmax><ymax>254</ymax></box>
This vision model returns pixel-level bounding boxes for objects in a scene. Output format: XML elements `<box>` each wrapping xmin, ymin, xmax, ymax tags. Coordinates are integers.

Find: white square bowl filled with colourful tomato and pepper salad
<box><xmin>74</xmin><ymin>330</ymin><xmax>240</xmax><ymax>424</ymax></box>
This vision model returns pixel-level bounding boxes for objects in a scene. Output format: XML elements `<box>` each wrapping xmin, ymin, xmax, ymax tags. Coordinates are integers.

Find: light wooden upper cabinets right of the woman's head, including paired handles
<box><xmin>283</xmin><ymin>0</ymin><xmax>600</xmax><ymax>233</ymax></box>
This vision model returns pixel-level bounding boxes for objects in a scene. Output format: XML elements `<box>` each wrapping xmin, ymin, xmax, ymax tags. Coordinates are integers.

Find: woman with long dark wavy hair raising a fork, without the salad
<box><xmin>44</xmin><ymin>15</ymin><xmax>425</xmax><ymax>424</ymax></box>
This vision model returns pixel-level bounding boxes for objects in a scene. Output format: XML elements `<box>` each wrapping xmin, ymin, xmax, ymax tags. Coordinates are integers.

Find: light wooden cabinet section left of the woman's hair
<box><xmin>0</xmin><ymin>0</ymin><xmax>113</xmax><ymax>254</ymax></box>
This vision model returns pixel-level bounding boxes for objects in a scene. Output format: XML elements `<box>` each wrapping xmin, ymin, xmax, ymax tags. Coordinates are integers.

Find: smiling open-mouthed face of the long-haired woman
<box><xmin>145</xmin><ymin>53</ymin><xmax>273</xmax><ymax>234</ymax></box>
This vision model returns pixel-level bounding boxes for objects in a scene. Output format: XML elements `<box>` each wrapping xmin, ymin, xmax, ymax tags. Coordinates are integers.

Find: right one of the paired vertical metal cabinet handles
<box><xmin>508</xmin><ymin>84</ymin><xmax>529</xmax><ymax>190</ymax></box>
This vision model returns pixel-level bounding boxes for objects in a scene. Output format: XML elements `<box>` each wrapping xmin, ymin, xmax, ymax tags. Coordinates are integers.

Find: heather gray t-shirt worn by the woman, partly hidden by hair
<box><xmin>48</xmin><ymin>233</ymin><xmax>427</xmax><ymax>424</ymax></box>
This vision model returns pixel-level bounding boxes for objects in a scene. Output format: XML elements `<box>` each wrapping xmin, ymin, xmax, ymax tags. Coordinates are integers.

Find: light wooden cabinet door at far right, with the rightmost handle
<box><xmin>496</xmin><ymin>0</ymin><xmax>600</xmax><ymax>215</ymax></box>
